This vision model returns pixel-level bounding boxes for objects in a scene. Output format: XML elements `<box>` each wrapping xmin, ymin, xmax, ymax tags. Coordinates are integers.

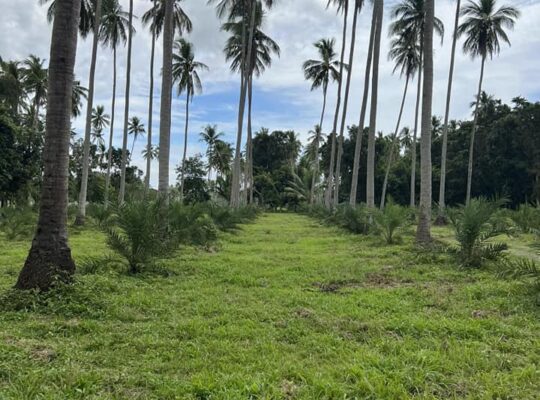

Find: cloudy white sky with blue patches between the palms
<box><xmin>0</xmin><ymin>0</ymin><xmax>540</xmax><ymax>186</ymax></box>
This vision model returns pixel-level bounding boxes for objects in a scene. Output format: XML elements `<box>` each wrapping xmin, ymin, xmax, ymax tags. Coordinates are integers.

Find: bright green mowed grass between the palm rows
<box><xmin>0</xmin><ymin>214</ymin><xmax>540</xmax><ymax>400</ymax></box>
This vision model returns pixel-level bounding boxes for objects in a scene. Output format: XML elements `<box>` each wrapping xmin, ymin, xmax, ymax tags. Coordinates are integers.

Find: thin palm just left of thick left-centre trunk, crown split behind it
<box><xmin>142</xmin><ymin>0</ymin><xmax>193</xmax><ymax>191</ymax></box>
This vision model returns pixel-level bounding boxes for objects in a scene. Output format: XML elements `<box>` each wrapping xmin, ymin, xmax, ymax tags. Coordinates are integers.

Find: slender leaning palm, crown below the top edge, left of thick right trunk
<box><xmin>380</xmin><ymin>27</ymin><xmax>420</xmax><ymax>210</ymax></box>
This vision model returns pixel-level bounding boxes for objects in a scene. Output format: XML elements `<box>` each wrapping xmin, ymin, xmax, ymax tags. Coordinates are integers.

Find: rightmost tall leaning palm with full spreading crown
<box><xmin>458</xmin><ymin>0</ymin><xmax>519</xmax><ymax>204</ymax></box>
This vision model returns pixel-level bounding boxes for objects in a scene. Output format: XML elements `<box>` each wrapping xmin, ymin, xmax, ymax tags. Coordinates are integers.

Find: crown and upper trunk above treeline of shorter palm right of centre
<box><xmin>302</xmin><ymin>39</ymin><xmax>339</xmax><ymax>129</ymax></box>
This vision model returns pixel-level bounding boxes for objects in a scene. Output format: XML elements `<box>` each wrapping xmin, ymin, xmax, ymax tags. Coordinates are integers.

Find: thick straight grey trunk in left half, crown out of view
<box><xmin>158</xmin><ymin>0</ymin><xmax>174</xmax><ymax>201</ymax></box>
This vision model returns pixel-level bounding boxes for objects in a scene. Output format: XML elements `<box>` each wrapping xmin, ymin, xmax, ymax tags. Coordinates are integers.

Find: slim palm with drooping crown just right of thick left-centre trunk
<box><xmin>172</xmin><ymin>38</ymin><xmax>208</xmax><ymax>196</ymax></box>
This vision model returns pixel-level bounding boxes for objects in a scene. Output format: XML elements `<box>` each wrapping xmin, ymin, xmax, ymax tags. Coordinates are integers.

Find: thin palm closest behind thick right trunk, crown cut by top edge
<box><xmin>390</xmin><ymin>0</ymin><xmax>444</xmax><ymax>207</ymax></box>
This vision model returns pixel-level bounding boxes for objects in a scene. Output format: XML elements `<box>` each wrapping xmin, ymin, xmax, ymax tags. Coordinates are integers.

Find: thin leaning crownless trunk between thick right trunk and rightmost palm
<box><xmin>438</xmin><ymin>0</ymin><xmax>461</xmax><ymax>222</ymax></box>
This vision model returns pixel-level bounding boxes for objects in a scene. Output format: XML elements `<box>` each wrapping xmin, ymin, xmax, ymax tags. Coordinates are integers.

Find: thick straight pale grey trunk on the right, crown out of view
<box><xmin>416</xmin><ymin>0</ymin><xmax>435</xmax><ymax>244</ymax></box>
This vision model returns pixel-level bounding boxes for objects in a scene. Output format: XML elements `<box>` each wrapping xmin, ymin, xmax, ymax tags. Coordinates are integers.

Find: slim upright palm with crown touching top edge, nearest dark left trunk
<box><xmin>100</xmin><ymin>0</ymin><xmax>129</xmax><ymax>205</ymax></box>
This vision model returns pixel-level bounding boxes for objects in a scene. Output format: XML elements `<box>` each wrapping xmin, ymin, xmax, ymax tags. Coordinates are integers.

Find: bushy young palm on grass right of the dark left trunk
<box><xmin>106</xmin><ymin>201</ymin><xmax>178</xmax><ymax>273</ymax></box>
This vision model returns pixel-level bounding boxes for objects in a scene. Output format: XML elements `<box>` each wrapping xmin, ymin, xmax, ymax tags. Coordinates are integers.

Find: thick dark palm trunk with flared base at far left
<box><xmin>15</xmin><ymin>0</ymin><xmax>81</xmax><ymax>290</ymax></box>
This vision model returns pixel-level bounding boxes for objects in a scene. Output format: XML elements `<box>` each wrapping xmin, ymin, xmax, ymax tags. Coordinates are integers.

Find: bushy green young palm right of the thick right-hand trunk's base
<box><xmin>448</xmin><ymin>198</ymin><xmax>508</xmax><ymax>267</ymax></box>
